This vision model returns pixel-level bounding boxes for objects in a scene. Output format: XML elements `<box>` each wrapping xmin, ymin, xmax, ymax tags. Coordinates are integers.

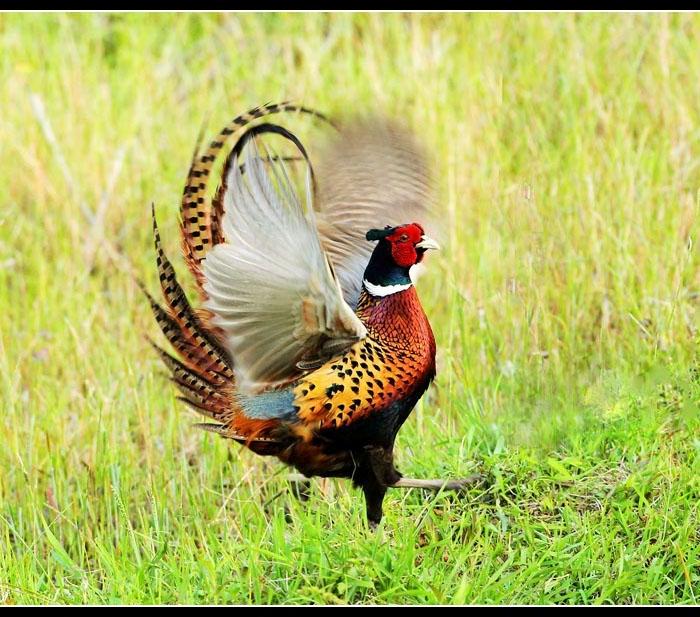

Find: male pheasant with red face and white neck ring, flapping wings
<box><xmin>144</xmin><ymin>103</ymin><xmax>476</xmax><ymax>527</ymax></box>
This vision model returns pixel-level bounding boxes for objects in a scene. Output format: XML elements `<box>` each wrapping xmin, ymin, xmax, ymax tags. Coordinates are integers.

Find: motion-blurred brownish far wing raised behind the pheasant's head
<box><xmin>317</xmin><ymin>119</ymin><xmax>434</xmax><ymax>307</ymax></box>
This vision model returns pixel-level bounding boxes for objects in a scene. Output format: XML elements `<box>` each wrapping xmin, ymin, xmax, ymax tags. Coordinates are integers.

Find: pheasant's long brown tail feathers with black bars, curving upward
<box><xmin>142</xmin><ymin>102</ymin><xmax>330</xmax><ymax>454</ymax></box>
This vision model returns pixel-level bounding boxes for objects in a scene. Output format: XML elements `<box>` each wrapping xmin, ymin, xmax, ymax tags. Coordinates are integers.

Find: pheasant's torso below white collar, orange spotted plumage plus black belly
<box><xmin>286</xmin><ymin>287</ymin><xmax>435</xmax><ymax>477</ymax></box>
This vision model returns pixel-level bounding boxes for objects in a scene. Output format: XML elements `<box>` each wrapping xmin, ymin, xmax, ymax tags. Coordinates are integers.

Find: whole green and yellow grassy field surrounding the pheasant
<box><xmin>0</xmin><ymin>14</ymin><xmax>700</xmax><ymax>604</ymax></box>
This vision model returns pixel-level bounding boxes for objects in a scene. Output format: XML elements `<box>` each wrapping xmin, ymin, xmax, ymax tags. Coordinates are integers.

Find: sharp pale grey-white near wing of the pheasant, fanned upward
<box><xmin>204</xmin><ymin>140</ymin><xmax>369</xmax><ymax>392</ymax></box>
